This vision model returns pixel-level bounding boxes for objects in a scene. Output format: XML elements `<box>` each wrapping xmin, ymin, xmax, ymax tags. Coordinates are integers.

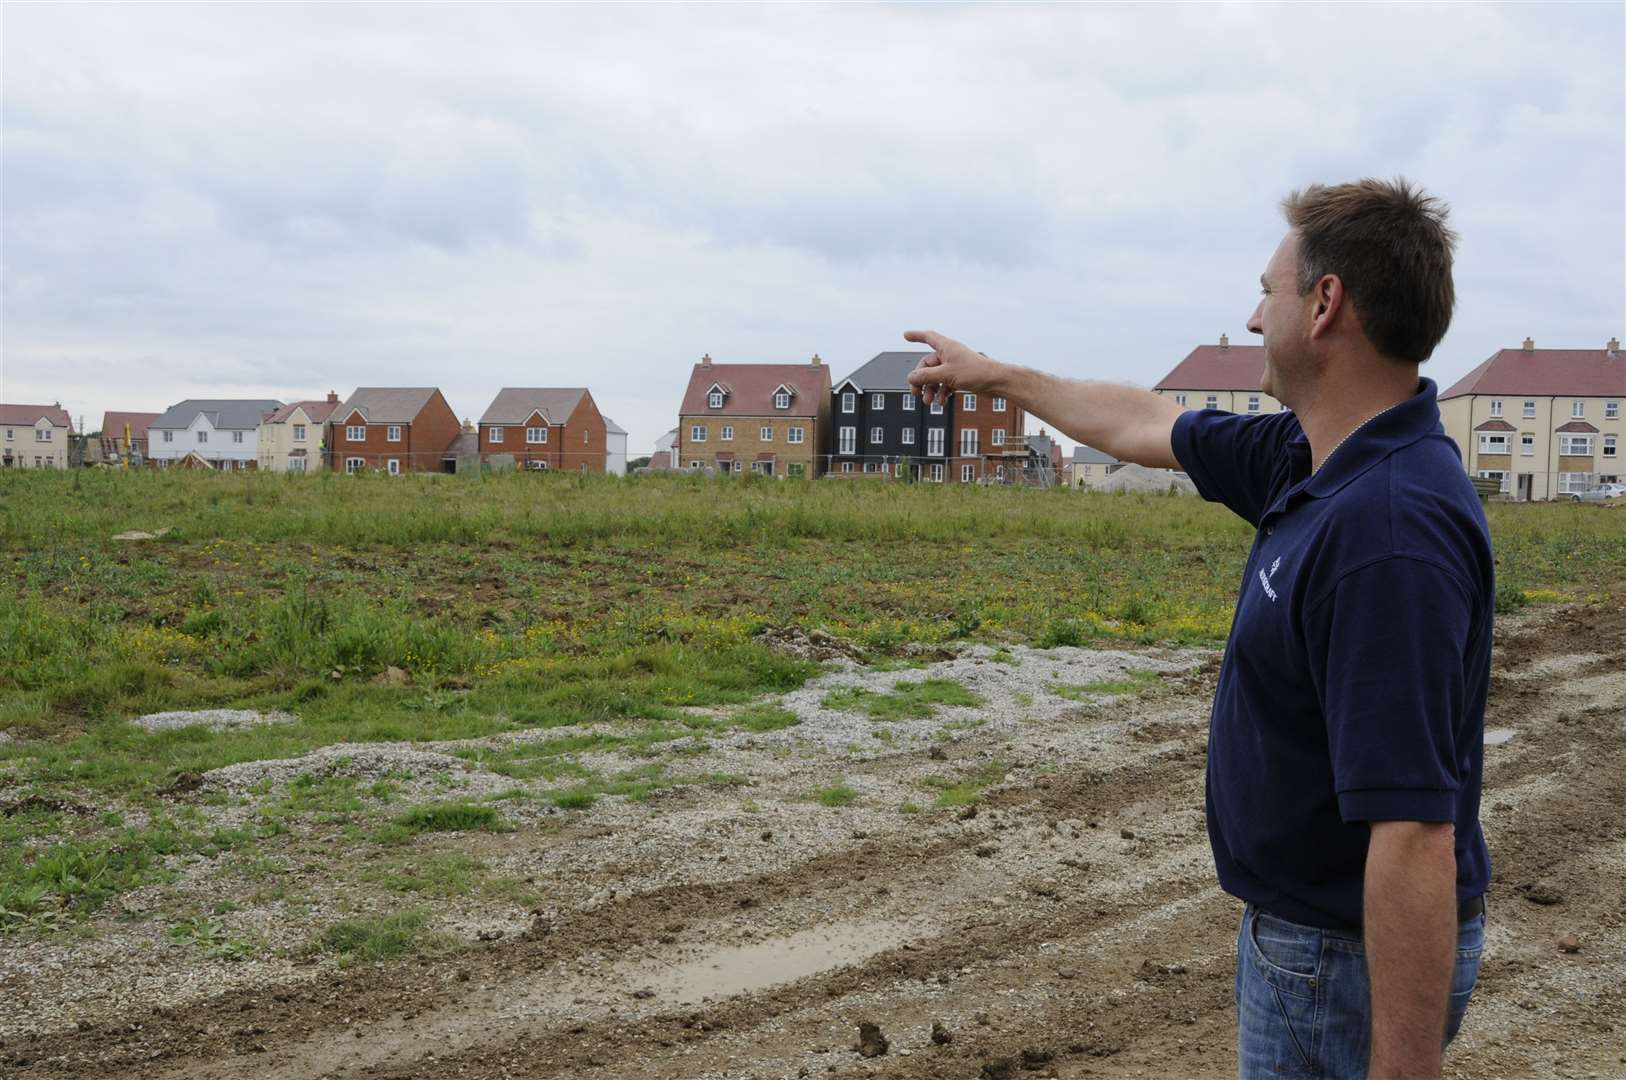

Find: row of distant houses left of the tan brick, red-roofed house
<box><xmin>0</xmin><ymin>387</ymin><xmax>626</xmax><ymax>473</ymax></box>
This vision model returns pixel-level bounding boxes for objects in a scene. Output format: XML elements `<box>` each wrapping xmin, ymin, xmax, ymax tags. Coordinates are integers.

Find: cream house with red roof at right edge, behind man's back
<box><xmin>1439</xmin><ymin>338</ymin><xmax>1626</xmax><ymax>499</ymax></box>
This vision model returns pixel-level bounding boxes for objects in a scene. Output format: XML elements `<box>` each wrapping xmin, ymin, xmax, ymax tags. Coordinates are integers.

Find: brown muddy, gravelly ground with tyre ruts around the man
<box><xmin>0</xmin><ymin>605</ymin><xmax>1626</xmax><ymax>1080</ymax></box>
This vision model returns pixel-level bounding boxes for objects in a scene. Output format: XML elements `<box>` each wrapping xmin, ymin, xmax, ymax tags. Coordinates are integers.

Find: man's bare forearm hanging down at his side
<box><xmin>1364</xmin><ymin>821</ymin><xmax>1457</xmax><ymax>1080</ymax></box>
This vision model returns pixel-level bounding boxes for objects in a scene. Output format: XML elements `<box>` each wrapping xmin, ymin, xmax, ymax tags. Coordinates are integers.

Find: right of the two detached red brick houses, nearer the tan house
<box><xmin>480</xmin><ymin>387</ymin><xmax>608</xmax><ymax>473</ymax></box>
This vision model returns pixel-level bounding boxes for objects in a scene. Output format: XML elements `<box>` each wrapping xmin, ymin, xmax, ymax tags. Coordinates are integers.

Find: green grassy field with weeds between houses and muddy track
<box><xmin>0</xmin><ymin>472</ymin><xmax>1626</xmax><ymax>930</ymax></box>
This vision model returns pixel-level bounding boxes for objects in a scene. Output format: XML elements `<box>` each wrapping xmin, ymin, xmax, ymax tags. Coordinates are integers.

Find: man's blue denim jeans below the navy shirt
<box><xmin>1236</xmin><ymin>904</ymin><xmax>1485</xmax><ymax>1080</ymax></box>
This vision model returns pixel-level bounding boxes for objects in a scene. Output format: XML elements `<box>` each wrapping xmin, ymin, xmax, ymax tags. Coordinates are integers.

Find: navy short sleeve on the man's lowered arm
<box><xmin>1304</xmin><ymin>555</ymin><xmax>1473</xmax><ymax>821</ymax></box>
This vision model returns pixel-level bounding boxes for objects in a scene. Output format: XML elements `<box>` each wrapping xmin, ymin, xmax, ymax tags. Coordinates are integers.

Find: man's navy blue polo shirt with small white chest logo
<box><xmin>1174</xmin><ymin>379</ymin><xmax>1496</xmax><ymax>929</ymax></box>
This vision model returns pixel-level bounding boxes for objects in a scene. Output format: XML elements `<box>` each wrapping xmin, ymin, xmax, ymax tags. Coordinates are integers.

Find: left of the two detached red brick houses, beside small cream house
<box><xmin>327</xmin><ymin>387</ymin><xmax>462</xmax><ymax>475</ymax></box>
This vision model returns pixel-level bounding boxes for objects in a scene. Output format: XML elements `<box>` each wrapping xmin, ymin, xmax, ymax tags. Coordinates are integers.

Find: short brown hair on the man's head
<box><xmin>1281</xmin><ymin>177</ymin><xmax>1457</xmax><ymax>364</ymax></box>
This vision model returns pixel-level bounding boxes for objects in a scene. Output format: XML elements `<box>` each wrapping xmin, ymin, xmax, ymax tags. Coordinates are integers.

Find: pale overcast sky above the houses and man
<box><xmin>0</xmin><ymin>3</ymin><xmax>1626</xmax><ymax>455</ymax></box>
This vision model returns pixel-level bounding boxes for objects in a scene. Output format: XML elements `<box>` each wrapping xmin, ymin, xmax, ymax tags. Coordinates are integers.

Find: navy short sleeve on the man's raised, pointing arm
<box><xmin>1169</xmin><ymin>408</ymin><xmax>1301</xmax><ymax>527</ymax></box>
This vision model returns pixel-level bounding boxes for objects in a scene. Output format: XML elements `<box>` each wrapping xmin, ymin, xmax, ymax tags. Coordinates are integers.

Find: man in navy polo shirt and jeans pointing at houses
<box><xmin>904</xmin><ymin>181</ymin><xmax>1494</xmax><ymax>1080</ymax></box>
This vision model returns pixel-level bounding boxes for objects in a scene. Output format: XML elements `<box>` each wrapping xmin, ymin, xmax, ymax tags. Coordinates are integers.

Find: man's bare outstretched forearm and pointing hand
<box><xmin>904</xmin><ymin>330</ymin><xmax>1182</xmax><ymax>468</ymax></box>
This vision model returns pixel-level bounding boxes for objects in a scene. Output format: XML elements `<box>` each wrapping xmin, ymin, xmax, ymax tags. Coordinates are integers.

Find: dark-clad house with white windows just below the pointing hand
<box><xmin>824</xmin><ymin>353</ymin><xmax>954</xmax><ymax>483</ymax></box>
